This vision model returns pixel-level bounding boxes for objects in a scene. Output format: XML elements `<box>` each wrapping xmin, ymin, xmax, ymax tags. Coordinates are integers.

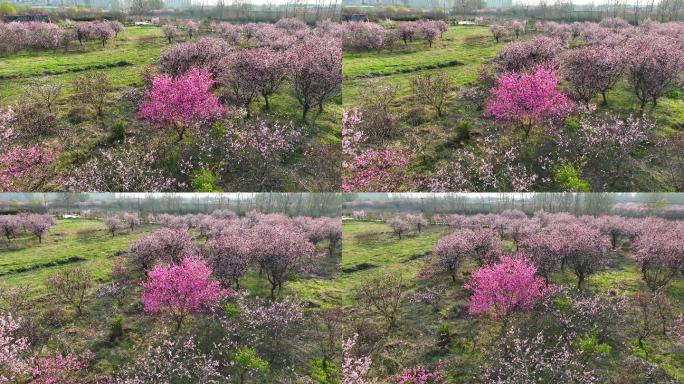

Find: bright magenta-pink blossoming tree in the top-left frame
<box><xmin>138</xmin><ymin>68</ymin><xmax>225</xmax><ymax>141</ymax></box>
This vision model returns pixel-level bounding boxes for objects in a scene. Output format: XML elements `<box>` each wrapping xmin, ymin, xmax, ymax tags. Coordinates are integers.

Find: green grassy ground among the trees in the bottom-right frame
<box><xmin>342</xmin><ymin>221</ymin><xmax>684</xmax><ymax>382</ymax></box>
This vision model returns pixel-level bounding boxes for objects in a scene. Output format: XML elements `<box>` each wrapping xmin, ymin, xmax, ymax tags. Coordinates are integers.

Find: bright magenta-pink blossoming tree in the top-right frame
<box><xmin>487</xmin><ymin>66</ymin><xmax>575</xmax><ymax>138</ymax></box>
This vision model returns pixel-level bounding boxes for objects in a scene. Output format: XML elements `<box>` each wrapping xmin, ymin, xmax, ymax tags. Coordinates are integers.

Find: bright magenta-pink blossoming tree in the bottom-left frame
<box><xmin>140</xmin><ymin>256</ymin><xmax>228</xmax><ymax>330</ymax></box>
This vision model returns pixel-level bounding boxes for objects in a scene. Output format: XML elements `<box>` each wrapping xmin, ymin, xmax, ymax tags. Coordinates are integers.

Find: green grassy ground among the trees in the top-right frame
<box><xmin>342</xmin><ymin>26</ymin><xmax>684</xmax><ymax>191</ymax></box>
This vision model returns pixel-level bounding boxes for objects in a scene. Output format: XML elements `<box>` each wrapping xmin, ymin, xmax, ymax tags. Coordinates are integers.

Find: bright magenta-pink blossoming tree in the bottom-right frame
<box><xmin>464</xmin><ymin>256</ymin><xmax>544</xmax><ymax>322</ymax></box>
